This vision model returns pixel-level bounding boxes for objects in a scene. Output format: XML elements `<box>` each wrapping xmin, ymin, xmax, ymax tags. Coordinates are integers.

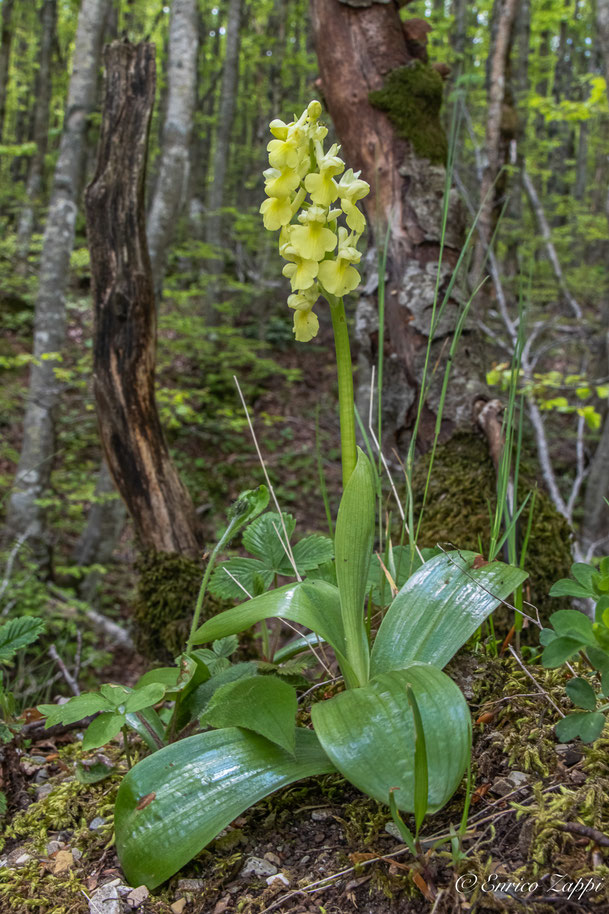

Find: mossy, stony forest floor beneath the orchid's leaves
<box><xmin>0</xmin><ymin>651</ymin><xmax>609</xmax><ymax>914</ymax></box>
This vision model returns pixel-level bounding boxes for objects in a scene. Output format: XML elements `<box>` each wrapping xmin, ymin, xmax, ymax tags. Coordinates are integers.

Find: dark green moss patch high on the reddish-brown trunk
<box><xmin>368</xmin><ymin>60</ymin><xmax>448</xmax><ymax>165</ymax></box>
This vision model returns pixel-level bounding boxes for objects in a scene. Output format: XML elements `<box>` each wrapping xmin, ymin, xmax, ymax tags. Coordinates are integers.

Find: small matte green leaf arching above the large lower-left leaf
<box><xmin>202</xmin><ymin>676</ymin><xmax>298</xmax><ymax>754</ymax></box>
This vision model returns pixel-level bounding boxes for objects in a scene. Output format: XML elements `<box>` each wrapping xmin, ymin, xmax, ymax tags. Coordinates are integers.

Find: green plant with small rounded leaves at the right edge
<box><xmin>539</xmin><ymin>556</ymin><xmax>609</xmax><ymax>743</ymax></box>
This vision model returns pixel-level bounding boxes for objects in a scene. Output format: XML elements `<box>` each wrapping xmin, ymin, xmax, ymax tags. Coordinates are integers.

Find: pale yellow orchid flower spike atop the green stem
<box><xmin>260</xmin><ymin>100</ymin><xmax>370</xmax><ymax>343</ymax></box>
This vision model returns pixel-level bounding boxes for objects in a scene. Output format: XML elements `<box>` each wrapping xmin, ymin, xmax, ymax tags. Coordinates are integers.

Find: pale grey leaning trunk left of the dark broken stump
<box><xmin>8</xmin><ymin>0</ymin><xmax>108</xmax><ymax>566</ymax></box>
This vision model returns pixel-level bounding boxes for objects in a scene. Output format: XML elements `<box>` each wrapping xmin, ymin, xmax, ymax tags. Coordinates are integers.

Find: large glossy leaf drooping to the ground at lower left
<box><xmin>114</xmin><ymin>727</ymin><xmax>334</xmax><ymax>889</ymax></box>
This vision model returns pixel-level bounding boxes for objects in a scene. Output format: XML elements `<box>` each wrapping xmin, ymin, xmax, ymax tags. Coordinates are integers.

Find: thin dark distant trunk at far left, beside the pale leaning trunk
<box><xmin>17</xmin><ymin>0</ymin><xmax>57</xmax><ymax>260</ymax></box>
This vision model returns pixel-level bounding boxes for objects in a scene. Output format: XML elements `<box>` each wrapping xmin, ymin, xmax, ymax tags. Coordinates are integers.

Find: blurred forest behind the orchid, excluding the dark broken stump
<box><xmin>0</xmin><ymin>0</ymin><xmax>609</xmax><ymax>707</ymax></box>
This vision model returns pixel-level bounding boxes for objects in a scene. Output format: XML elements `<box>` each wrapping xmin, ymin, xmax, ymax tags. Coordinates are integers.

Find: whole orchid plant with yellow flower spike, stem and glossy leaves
<box><xmin>107</xmin><ymin>101</ymin><xmax>526</xmax><ymax>889</ymax></box>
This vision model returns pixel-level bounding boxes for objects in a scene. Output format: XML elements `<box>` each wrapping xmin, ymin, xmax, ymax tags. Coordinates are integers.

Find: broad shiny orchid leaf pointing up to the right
<box><xmin>371</xmin><ymin>551</ymin><xmax>527</xmax><ymax>675</ymax></box>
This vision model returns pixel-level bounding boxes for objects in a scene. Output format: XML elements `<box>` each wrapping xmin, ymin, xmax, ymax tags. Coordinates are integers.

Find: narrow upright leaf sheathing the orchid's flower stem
<box><xmin>332</xmin><ymin>448</ymin><xmax>376</xmax><ymax>685</ymax></box>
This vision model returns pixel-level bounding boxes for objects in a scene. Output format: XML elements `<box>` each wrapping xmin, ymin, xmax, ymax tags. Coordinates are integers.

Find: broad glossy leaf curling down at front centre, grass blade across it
<box><xmin>311</xmin><ymin>663</ymin><xmax>471</xmax><ymax>812</ymax></box>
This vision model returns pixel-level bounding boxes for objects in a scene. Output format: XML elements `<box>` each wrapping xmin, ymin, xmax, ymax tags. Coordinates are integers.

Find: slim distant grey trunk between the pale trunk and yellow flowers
<box><xmin>205</xmin><ymin>0</ymin><xmax>243</xmax><ymax>274</ymax></box>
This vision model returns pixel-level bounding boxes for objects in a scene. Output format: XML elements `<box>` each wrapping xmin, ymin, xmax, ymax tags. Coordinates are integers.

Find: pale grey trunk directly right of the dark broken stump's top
<box><xmin>148</xmin><ymin>0</ymin><xmax>199</xmax><ymax>303</ymax></box>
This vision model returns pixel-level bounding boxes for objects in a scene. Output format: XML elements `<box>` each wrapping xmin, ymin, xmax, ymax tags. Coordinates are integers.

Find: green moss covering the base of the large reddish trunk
<box><xmin>413</xmin><ymin>432</ymin><xmax>573</xmax><ymax>619</ymax></box>
